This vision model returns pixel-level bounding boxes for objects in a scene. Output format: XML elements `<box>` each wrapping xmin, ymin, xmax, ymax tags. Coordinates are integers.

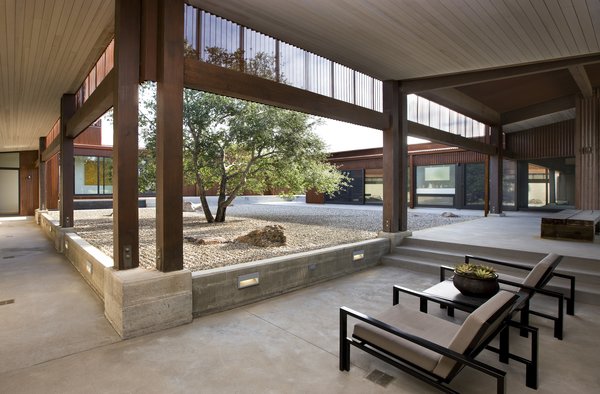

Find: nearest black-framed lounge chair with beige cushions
<box><xmin>340</xmin><ymin>291</ymin><xmax>538</xmax><ymax>393</ymax></box>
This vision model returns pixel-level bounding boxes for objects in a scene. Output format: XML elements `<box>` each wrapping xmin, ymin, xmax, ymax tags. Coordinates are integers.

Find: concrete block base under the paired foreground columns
<box><xmin>104</xmin><ymin>268</ymin><xmax>192</xmax><ymax>339</ymax></box>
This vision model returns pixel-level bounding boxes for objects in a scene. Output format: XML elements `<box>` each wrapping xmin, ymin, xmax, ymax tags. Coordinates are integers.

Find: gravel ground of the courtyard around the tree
<box><xmin>51</xmin><ymin>203</ymin><xmax>478</xmax><ymax>271</ymax></box>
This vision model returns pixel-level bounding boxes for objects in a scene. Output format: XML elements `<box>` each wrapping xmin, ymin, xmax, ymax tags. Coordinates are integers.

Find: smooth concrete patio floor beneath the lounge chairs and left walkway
<box><xmin>0</xmin><ymin>218</ymin><xmax>600</xmax><ymax>393</ymax></box>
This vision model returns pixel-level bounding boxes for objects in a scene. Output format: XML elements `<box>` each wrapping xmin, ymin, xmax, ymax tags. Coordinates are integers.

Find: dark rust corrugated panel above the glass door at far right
<box><xmin>506</xmin><ymin>119</ymin><xmax>575</xmax><ymax>160</ymax></box>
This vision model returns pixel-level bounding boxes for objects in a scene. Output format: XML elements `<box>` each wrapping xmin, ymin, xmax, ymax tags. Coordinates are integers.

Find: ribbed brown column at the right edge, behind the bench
<box><xmin>575</xmin><ymin>89</ymin><xmax>600</xmax><ymax>210</ymax></box>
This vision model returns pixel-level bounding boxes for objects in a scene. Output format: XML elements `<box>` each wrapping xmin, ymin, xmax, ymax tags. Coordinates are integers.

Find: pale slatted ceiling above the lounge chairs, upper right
<box><xmin>196</xmin><ymin>0</ymin><xmax>600</xmax><ymax>80</ymax></box>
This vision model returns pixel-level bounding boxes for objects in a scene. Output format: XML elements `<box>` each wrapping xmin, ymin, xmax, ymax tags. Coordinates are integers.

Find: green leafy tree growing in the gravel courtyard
<box><xmin>184</xmin><ymin>90</ymin><xmax>347</xmax><ymax>222</ymax></box>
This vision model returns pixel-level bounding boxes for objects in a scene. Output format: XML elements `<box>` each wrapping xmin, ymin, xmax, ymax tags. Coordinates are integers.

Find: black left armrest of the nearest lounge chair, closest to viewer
<box><xmin>340</xmin><ymin>306</ymin><xmax>506</xmax><ymax>377</ymax></box>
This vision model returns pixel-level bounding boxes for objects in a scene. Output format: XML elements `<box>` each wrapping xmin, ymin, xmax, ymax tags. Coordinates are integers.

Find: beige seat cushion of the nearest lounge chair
<box><xmin>353</xmin><ymin>305</ymin><xmax>460</xmax><ymax>371</ymax></box>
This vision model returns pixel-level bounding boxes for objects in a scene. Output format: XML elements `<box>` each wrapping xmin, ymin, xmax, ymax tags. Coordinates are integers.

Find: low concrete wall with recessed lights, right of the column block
<box><xmin>192</xmin><ymin>238</ymin><xmax>390</xmax><ymax>317</ymax></box>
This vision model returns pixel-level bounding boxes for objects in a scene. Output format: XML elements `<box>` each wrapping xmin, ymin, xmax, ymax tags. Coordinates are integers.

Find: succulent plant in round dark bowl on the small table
<box><xmin>452</xmin><ymin>263</ymin><xmax>499</xmax><ymax>297</ymax></box>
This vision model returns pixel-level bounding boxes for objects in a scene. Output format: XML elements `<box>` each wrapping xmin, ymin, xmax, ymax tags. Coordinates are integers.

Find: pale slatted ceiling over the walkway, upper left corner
<box><xmin>0</xmin><ymin>0</ymin><xmax>114</xmax><ymax>151</ymax></box>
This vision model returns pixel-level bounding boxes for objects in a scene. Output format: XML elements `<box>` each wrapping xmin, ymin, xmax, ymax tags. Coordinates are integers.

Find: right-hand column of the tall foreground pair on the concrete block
<box><xmin>156</xmin><ymin>0</ymin><xmax>184</xmax><ymax>272</ymax></box>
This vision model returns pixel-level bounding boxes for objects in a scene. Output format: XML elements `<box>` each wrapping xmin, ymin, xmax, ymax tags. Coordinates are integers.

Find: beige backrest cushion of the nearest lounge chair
<box><xmin>433</xmin><ymin>291</ymin><xmax>514</xmax><ymax>378</ymax></box>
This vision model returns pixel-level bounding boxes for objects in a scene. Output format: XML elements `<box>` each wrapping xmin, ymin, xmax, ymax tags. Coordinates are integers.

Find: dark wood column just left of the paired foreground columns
<box><xmin>58</xmin><ymin>94</ymin><xmax>76</xmax><ymax>227</ymax></box>
